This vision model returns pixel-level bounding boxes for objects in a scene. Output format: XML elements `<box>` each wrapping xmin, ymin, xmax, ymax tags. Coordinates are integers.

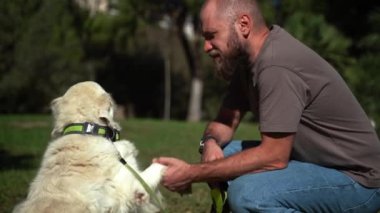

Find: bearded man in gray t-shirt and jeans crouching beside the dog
<box><xmin>154</xmin><ymin>0</ymin><xmax>380</xmax><ymax>213</ymax></box>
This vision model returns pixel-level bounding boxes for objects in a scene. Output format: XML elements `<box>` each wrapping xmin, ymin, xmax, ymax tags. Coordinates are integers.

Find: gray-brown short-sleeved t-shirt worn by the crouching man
<box><xmin>223</xmin><ymin>26</ymin><xmax>380</xmax><ymax>187</ymax></box>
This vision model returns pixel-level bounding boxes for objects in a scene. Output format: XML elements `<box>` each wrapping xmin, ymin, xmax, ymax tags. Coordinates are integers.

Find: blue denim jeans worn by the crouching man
<box><xmin>224</xmin><ymin>141</ymin><xmax>380</xmax><ymax>213</ymax></box>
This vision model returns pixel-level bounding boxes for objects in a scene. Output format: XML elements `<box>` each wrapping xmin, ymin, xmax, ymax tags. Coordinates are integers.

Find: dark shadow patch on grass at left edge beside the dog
<box><xmin>0</xmin><ymin>149</ymin><xmax>37</xmax><ymax>171</ymax></box>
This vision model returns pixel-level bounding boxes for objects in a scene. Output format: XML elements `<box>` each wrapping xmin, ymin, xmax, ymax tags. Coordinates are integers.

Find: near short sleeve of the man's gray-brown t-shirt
<box><xmin>257</xmin><ymin>66</ymin><xmax>309</xmax><ymax>132</ymax></box>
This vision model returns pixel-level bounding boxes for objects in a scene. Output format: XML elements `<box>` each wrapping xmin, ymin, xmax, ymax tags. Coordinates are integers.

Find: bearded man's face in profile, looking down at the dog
<box><xmin>201</xmin><ymin>4</ymin><xmax>249</xmax><ymax>81</ymax></box>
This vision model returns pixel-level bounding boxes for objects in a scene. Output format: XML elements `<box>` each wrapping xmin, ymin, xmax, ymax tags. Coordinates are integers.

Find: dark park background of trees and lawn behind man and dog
<box><xmin>0</xmin><ymin>0</ymin><xmax>380</xmax><ymax>213</ymax></box>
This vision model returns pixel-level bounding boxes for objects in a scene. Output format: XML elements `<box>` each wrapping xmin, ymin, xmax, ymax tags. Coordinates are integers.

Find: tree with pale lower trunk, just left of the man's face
<box><xmin>134</xmin><ymin>0</ymin><xmax>203</xmax><ymax>121</ymax></box>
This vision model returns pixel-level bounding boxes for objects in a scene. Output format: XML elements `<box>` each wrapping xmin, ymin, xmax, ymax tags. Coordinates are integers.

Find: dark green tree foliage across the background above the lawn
<box><xmin>0</xmin><ymin>0</ymin><xmax>380</xmax><ymax>126</ymax></box>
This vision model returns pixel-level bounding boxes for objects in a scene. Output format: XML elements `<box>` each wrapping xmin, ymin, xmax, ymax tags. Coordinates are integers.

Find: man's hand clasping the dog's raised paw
<box><xmin>153</xmin><ymin>157</ymin><xmax>194</xmax><ymax>193</ymax></box>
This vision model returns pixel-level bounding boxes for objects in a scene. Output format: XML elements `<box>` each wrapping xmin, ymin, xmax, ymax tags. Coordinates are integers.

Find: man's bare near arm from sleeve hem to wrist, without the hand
<box><xmin>190</xmin><ymin>133</ymin><xmax>294</xmax><ymax>182</ymax></box>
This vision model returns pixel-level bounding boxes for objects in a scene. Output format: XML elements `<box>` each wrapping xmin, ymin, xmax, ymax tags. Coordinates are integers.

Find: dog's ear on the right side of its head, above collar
<box><xmin>99</xmin><ymin>93</ymin><xmax>120</xmax><ymax>130</ymax></box>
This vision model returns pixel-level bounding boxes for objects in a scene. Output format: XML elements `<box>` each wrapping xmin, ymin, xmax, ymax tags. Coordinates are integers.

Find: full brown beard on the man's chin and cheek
<box><xmin>215</xmin><ymin>29</ymin><xmax>250</xmax><ymax>81</ymax></box>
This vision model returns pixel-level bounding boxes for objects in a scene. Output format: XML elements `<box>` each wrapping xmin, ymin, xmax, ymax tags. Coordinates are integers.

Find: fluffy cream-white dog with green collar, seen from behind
<box><xmin>14</xmin><ymin>82</ymin><xmax>165</xmax><ymax>213</ymax></box>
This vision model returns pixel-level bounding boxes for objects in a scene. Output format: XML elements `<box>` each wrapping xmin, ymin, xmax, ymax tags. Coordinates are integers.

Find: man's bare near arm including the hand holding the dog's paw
<box><xmin>154</xmin><ymin>133</ymin><xmax>295</xmax><ymax>191</ymax></box>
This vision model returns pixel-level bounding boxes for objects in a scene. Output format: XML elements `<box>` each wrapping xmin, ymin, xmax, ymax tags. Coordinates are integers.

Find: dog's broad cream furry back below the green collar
<box><xmin>14</xmin><ymin>135</ymin><xmax>139</xmax><ymax>212</ymax></box>
